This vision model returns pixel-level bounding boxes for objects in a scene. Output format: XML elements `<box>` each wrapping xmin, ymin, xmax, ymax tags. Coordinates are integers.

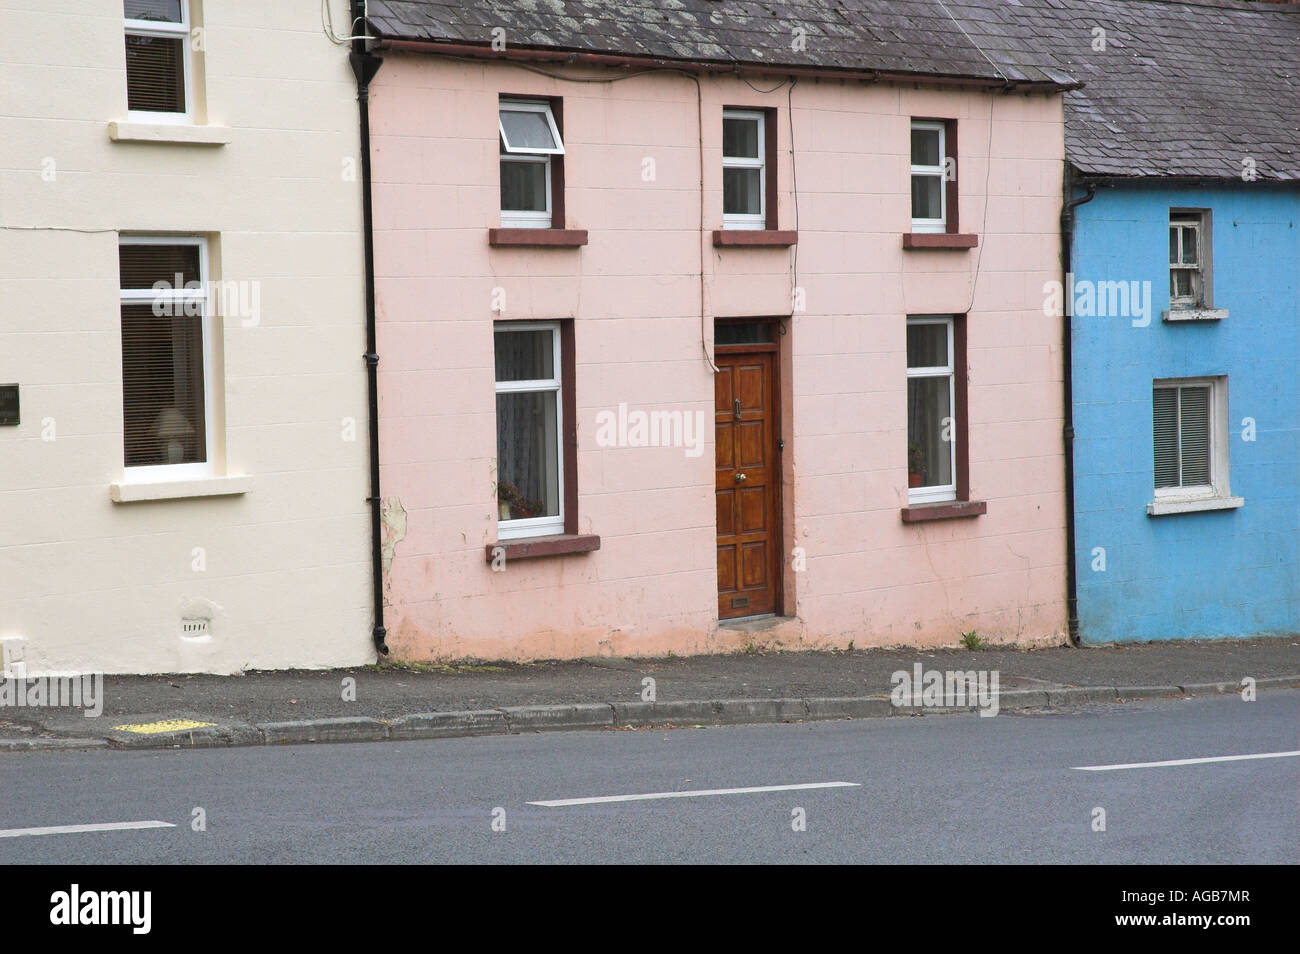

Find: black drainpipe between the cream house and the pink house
<box><xmin>347</xmin><ymin>0</ymin><xmax>389</xmax><ymax>656</ymax></box>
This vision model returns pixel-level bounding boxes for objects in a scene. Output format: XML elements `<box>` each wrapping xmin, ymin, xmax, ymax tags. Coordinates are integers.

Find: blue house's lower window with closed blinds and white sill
<box><xmin>1147</xmin><ymin>377</ymin><xmax>1242</xmax><ymax>515</ymax></box>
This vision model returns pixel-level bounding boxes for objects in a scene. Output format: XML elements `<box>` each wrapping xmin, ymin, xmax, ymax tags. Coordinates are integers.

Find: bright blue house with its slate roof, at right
<box><xmin>1056</xmin><ymin>0</ymin><xmax>1300</xmax><ymax>643</ymax></box>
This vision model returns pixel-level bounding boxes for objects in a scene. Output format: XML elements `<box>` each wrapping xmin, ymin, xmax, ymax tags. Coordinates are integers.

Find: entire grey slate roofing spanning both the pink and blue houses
<box><xmin>369</xmin><ymin>0</ymin><xmax>1300</xmax><ymax>181</ymax></box>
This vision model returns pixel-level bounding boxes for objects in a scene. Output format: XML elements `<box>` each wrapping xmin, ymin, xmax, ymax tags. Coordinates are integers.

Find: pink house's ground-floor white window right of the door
<box><xmin>907</xmin><ymin>316</ymin><xmax>957</xmax><ymax>503</ymax></box>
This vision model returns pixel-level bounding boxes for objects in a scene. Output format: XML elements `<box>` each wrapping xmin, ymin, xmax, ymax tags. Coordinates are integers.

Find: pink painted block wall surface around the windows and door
<box><xmin>372</xmin><ymin>53</ymin><xmax>1065</xmax><ymax>659</ymax></box>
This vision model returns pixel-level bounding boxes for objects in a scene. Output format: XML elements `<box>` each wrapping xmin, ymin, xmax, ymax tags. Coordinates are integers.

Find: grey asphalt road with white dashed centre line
<box><xmin>0</xmin><ymin>690</ymin><xmax>1300</xmax><ymax>864</ymax></box>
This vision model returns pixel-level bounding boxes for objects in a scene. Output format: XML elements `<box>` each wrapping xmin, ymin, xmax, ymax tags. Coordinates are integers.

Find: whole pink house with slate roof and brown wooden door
<box><xmin>365</xmin><ymin>0</ymin><xmax>1073</xmax><ymax>660</ymax></box>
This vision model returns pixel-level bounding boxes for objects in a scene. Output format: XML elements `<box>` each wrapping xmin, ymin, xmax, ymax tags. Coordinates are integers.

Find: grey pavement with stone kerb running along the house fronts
<box><xmin>0</xmin><ymin>638</ymin><xmax>1300</xmax><ymax>753</ymax></box>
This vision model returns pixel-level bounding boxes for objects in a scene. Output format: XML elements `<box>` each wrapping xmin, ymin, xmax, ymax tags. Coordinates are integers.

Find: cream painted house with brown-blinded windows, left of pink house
<box><xmin>0</xmin><ymin>0</ymin><xmax>374</xmax><ymax>675</ymax></box>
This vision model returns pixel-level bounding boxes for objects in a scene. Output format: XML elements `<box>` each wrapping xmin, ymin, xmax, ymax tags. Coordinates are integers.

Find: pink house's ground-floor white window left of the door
<box><xmin>493</xmin><ymin>321</ymin><xmax>564</xmax><ymax>539</ymax></box>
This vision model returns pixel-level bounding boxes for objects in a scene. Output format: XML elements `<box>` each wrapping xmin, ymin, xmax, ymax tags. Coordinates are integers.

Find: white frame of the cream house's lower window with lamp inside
<box><xmin>117</xmin><ymin>233</ymin><xmax>217</xmax><ymax>483</ymax></box>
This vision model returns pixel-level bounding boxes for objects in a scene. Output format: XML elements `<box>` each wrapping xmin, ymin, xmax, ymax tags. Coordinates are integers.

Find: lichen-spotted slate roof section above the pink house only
<box><xmin>368</xmin><ymin>0</ymin><xmax>1073</xmax><ymax>86</ymax></box>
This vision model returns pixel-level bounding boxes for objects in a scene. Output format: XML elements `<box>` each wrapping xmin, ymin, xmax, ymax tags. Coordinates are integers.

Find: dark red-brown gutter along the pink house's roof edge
<box><xmin>372</xmin><ymin>39</ymin><xmax>1083</xmax><ymax>92</ymax></box>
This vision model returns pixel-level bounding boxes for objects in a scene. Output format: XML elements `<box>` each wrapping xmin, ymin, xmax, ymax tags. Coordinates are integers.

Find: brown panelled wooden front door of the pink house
<box><xmin>714</xmin><ymin>344</ymin><xmax>784</xmax><ymax>620</ymax></box>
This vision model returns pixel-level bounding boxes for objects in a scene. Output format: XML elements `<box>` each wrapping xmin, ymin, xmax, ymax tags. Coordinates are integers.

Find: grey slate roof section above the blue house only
<box><xmin>1008</xmin><ymin>0</ymin><xmax>1300</xmax><ymax>181</ymax></box>
